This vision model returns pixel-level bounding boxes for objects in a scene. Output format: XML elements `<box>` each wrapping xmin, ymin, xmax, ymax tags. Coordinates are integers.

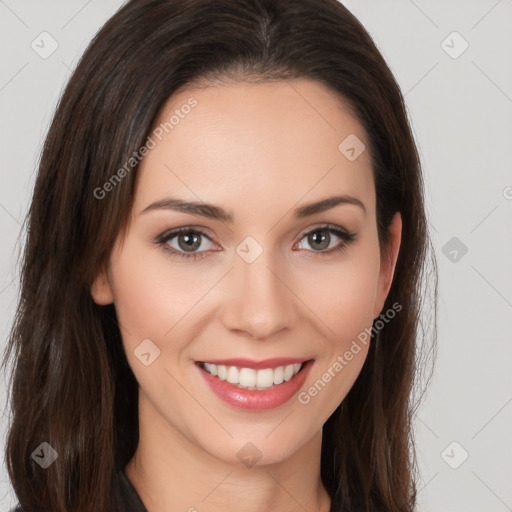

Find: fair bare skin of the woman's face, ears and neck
<box><xmin>91</xmin><ymin>80</ymin><xmax>401</xmax><ymax>512</ymax></box>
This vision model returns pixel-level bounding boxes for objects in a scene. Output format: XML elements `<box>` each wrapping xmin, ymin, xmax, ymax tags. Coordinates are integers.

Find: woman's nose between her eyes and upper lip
<box><xmin>223</xmin><ymin>251</ymin><xmax>297</xmax><ymax>340</ymax></box>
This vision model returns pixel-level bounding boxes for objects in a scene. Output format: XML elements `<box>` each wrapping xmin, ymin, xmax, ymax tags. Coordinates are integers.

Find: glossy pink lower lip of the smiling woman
<box><xmin>196</xmin><ymin>360</ymin><xmax>314</xmax><ymax>411</ymax></box>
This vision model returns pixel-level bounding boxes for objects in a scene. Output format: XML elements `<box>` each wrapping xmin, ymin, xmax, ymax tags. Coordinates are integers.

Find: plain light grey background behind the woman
<box><xmin>0</xmin><ymin>0</ymin><xmax>512</xmax><ymax>512</ymax></box>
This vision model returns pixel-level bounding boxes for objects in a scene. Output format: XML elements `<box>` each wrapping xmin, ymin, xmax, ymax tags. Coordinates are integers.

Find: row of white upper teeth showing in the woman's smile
<box><xmin>204</xmin><ymin>363</ymin><xmax>302</xmax><ymax>390</ymax></box>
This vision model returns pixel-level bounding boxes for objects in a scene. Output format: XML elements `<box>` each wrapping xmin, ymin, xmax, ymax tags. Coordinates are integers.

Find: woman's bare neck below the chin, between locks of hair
<box><xmin>125</xmin><ymin>394</ymin><xmax>330</xmax><ymax>512</ymax></box>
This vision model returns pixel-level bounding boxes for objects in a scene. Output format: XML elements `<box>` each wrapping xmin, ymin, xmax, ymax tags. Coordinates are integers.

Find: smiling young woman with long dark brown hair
<box><xmin>4</xmin><ymin>0</ymin><xmax>436</xmax><ymax>512</ymax></box>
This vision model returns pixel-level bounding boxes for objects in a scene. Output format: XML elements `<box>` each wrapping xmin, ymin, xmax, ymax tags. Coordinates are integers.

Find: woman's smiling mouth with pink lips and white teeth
<box><xmin>195</xmin><ymin>358</ymin><xmax>314</xmax><ymax>410</ymax></box>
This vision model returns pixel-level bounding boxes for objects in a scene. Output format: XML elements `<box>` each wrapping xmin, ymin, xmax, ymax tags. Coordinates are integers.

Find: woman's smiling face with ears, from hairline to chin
<box><xmin>92</xmin><ymin>80</ymin><xmax>401</xmax><ymax>464</ymax></box>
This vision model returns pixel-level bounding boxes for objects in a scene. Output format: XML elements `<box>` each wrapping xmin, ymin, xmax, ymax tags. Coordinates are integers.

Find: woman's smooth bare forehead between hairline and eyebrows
<box><xmin>135</xmin><ymin>80</ymin><xmax>375</xmax><ymax>222</ymax></box>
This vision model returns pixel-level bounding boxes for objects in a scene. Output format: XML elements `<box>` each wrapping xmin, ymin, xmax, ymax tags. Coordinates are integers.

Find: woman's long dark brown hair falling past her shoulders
<box><xmin>2</xmin><ymin>0</ymin><xmax>435</xmax><ymax>512</ymax></box>
